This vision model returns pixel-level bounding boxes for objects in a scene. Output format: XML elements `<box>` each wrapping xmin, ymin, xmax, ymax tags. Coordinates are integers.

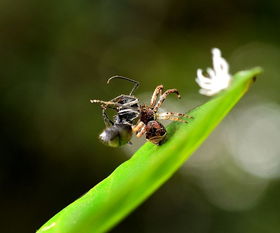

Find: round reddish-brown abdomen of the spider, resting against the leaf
<box><xmin>146</xmin><ymin>121</ymin><xmax>166</xmax><ymax>145</ymax></box>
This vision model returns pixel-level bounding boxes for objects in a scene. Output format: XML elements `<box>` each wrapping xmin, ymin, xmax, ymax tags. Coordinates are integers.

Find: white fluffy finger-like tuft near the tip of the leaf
<box><xmin>195</xmin><ymin>48</ymin><xmax>231</xmax><ymax>96</ymax></box>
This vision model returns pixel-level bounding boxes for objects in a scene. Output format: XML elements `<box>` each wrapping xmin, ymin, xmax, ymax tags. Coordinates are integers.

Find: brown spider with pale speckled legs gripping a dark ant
<box><xmin>132</xmin><ymin>85</ymin><xmax>192</xmax><ymax>145</ymax></box>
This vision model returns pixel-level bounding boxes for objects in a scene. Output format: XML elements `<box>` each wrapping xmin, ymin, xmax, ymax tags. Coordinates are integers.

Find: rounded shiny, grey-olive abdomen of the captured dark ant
<box><xmin>99</xmin><ymin>124</ymin><xmax>132</xmax><ymax>147</ymax></box>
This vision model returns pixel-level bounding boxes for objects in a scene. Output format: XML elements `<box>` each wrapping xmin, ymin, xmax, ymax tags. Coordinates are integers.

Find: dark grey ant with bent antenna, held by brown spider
<box><xmin>91</xmin><ymin>76</ymin><xmax>140</xmax><ymax>147</ymax></box>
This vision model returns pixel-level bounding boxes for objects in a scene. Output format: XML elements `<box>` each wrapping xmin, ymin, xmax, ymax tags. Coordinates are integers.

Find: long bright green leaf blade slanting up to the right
<box><xmin>38</xmin><ymin>68</ymin><xmax>261</xmax><ymax>233</ymax></box>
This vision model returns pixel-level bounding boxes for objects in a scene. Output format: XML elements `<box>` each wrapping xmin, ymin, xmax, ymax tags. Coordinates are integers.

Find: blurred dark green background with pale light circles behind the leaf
<box><xmin>0</xmin><ymin>0</ymin><xmax>280</xmax><ymax>233</ymax></box>
